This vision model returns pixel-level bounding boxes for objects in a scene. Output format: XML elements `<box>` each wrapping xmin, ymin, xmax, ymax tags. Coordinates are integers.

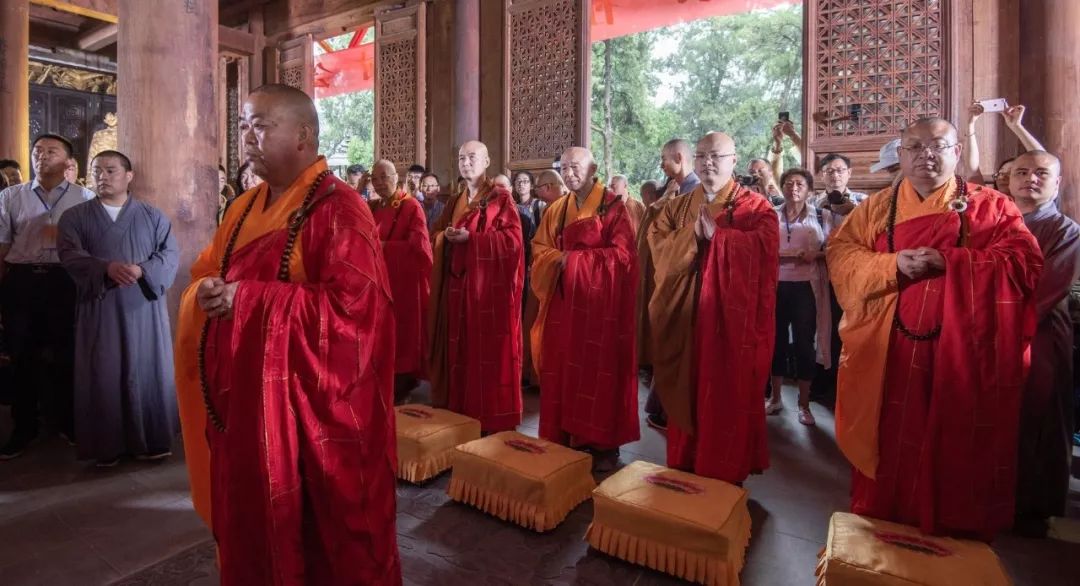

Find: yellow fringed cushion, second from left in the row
<box><xmin>447</xmin><ymin>432</ymin><xmax>596</xmax><ymax>531</ymax></box>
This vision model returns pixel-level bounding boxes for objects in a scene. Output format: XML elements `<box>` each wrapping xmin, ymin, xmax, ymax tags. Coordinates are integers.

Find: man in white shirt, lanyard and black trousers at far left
<box><xmin>0</xmin><ymin>134</ymin><xmax>94</xmax><ymax>460</ymax></box>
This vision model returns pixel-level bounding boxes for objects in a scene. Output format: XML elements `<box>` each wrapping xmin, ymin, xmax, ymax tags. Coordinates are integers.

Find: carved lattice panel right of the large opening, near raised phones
<box><xmin>805</xmin><ymin>0</ymin><xmax>951</xmax><ymax>189</ymax></box>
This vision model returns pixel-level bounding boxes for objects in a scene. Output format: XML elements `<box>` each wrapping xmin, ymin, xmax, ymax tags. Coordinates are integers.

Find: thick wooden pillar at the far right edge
<box><xmin>1020</xmin><ymin>0</ymin><xmax>1080</xmax><ymax>221</ymax></box>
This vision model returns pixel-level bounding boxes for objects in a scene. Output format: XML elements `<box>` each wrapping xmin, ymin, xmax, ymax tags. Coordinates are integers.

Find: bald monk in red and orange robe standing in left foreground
<box><xmin>176</xmin><ymin>84</ymin><xmax>402</xmax><ymax>586</ymax></box>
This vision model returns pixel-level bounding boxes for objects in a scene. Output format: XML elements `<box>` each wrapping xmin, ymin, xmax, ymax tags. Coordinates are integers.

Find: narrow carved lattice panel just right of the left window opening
<box><xmin>375</xmin><ymin>2</ymin><xmax>427</xmax><ymax>177</ymax></box>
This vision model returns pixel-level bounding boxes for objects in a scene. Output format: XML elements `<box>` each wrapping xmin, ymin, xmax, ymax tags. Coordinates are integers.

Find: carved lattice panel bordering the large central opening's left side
<box><xmin>503</xmin><ymin>0</ymin><xmax>592</xmax><ymax>171</ymax></box>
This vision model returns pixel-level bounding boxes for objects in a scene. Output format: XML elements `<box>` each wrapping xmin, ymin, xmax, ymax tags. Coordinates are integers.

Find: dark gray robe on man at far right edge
<box><xmin>1016</xmin><ymin>202</ymin><xmax>1080</xmax><ymax>519</ymax></box>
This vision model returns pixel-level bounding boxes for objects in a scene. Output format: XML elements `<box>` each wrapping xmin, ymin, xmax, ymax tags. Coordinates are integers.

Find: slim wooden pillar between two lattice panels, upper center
<box><xmin>454</xmin><ymin>0</ymin><xmax>477</xmax><ymax>149</ymax></box>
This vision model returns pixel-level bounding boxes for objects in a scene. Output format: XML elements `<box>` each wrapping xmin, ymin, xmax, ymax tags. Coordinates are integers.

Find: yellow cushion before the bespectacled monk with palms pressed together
<box><xmin>585</xmin><ymin>462</ymin><xmax>751</xmax><ymax>586</ymax></box>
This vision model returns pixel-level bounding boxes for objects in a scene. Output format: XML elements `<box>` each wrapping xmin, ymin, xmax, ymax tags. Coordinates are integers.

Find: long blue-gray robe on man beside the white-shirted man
<box><xmin>57</xmin><ymin>197</ymin><xmax>179</xmax><ymax>460</ymax></box>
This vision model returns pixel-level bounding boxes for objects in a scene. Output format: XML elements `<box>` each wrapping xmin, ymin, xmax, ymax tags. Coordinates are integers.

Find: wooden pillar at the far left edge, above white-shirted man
<box><xmin>0</xmin><ymin>0</ymin><xmax>30</xmax><ymax>171</ymax></box>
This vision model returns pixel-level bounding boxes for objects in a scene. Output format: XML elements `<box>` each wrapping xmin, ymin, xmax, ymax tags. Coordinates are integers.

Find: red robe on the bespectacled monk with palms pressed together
<box><xmin>667</xmin><ymin>182</ymin><xmax>780</xmax><ymax>483</ymax></box>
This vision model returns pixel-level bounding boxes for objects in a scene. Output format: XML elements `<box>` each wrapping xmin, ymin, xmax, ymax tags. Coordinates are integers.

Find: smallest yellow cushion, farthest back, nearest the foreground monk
<box><xmin>394</xmin><ymin>405</ymin><xmax>480</xmax><ymax>482</ymax></box>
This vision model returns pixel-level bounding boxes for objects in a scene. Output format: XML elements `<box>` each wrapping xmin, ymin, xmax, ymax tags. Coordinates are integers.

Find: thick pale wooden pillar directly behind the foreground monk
<box><xmin>117</xmin><ymin>0</ymin><xmax>219</xmax><ymax>319</ymax></box>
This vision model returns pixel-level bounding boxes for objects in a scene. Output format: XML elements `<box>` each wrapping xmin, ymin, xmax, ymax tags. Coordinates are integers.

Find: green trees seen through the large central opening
<box><xmin>591</xmin><ymin>5</ymin><xmax>802</xmax><ymax>189</ymax></box>
